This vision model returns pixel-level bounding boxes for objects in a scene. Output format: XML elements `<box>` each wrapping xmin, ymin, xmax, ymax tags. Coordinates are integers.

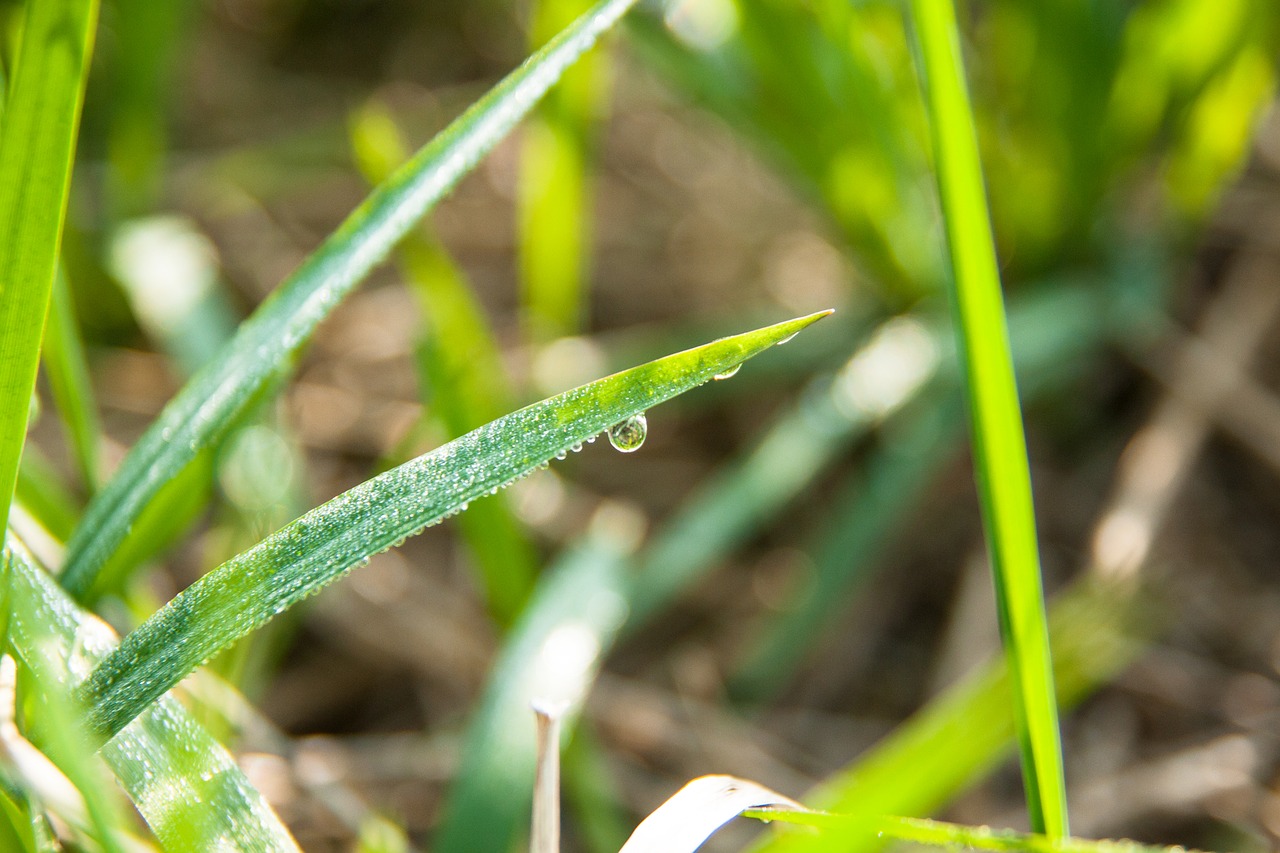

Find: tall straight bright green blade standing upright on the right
<box><xmin>911</xmin><ymin>0</ymin><xmax>1069</xmax><ymax>838</ymax></box>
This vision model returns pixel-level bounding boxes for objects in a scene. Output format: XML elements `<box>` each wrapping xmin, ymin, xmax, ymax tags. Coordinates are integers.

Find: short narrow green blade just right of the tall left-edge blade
<box><xmin>42</xmin><ymin>270</ymin><xmax>102</xmax><ymax>494</ymax></box>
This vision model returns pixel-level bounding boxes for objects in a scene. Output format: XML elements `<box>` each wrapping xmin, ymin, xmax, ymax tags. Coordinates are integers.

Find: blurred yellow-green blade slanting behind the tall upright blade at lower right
<box><xmin>751</xmin><ymin>573</ymin><xmax>1153</xmax><ymax>853</ymax></box>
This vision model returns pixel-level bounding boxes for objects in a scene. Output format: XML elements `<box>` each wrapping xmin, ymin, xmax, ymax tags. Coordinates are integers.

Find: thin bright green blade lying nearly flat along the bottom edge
<box><xmin>744</xmin><ymin>808</ymin><xmax>1194</xmax><ymax>853</ymax></box>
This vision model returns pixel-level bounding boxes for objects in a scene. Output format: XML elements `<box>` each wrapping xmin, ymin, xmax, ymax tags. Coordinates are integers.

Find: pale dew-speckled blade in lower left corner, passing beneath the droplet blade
<box><xmin>5</xmin><ymin>538</ymin><xmax>297</xmax><ymax>852</ymax></box>
